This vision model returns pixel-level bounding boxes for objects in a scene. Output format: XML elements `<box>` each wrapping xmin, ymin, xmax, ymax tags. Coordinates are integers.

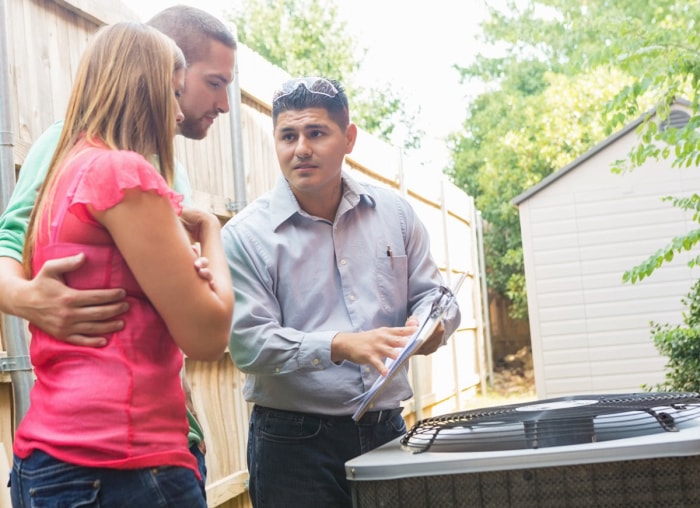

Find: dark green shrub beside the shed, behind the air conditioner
<box><xmin>648</xmin><ymin>281</ymin><xmax>700</xmax><ymax>392</ymax></box>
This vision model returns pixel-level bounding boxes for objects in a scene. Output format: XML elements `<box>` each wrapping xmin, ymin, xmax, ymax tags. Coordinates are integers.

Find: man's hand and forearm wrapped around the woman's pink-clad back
<box><xmin>0</xmin><ymin>254</ymin><xmax>129</xmax><ymax>347</ymax></box>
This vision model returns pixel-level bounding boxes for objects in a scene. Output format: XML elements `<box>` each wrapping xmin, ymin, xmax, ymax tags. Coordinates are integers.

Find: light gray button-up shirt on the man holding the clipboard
<box><xmin>222</xmin><ymin>173</ymin><xmax>460</xmax><ymax>415</ymax></box>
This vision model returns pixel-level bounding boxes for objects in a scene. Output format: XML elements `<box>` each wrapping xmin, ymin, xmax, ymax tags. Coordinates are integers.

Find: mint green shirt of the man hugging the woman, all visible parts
<box><xmin>0</xmin><ymin>120</ymin><xmax>204</xmax><ymax>446</ymax></box>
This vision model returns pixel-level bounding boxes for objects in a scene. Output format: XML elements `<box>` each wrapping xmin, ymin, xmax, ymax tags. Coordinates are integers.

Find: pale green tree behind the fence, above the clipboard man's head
<box><xmin>232</xmin><ymin>0</ymin><xmax>423</xmax><ymax>149</ymax></box>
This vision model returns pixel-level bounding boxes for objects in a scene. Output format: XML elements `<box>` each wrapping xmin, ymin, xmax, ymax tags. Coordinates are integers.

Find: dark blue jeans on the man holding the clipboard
<box><xmin>248</xmin><ymin>405</ymin><xmax>406</xmax><ymax>508</ymax></box>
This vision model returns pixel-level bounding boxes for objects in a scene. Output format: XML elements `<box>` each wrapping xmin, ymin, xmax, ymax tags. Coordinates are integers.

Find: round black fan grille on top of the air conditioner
<box><xmin>401</xmin><ymin>392</ymin><xmax>700</xmax><ymax>452</ymax></box>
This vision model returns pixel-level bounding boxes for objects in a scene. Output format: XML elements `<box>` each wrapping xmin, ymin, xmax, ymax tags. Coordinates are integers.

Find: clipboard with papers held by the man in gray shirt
<box><xmin>350</xmin><ymin>273</ymin><xmax>467</xmax><ymax>421</ymax></box>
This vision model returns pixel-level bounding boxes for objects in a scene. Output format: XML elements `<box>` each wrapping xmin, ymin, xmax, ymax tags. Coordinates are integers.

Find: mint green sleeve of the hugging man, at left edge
<box><xmin>0</xmin><ymin>121</ymin><xmax>63</xmax><ymax>263</ymax></box>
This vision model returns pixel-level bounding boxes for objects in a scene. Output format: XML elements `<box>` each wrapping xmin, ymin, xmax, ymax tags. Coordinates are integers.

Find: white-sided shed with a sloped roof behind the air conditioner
<box><xmin>513</xmin><ymin>103</ymin><xmax>700</xmax><ymax>398</ymax></box>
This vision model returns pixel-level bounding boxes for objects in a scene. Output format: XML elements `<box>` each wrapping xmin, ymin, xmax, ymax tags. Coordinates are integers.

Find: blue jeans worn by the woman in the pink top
<box><xmin>10</xmin><ymin>450</ymin><xmax>207</xmax><ymax>508</ymax></box>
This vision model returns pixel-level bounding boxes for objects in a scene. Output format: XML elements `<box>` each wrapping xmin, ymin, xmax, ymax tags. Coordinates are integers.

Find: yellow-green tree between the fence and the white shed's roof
<box><xmin>447</xmin><ymin>18</ymin><xmax>626</xmax><ymax>318</ymax></box>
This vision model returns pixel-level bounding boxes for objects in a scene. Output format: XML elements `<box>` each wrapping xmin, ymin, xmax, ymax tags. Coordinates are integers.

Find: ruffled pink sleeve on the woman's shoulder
<box><xmin>69</xmin><ymin>150</ymin><xmax>183</xmax><ymax>223</ymax></box>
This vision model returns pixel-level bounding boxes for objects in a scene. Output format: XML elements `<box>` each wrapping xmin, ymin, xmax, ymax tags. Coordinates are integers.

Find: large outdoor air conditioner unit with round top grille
<box><xmin>345</xmin><ymin>392</ymin><xmax>700</xmax><ymax>508</ymax></box>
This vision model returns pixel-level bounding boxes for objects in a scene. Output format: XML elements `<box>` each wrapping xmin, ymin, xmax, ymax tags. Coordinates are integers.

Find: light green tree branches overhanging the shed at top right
<box><xmin>490</xmin><ymin>0</ymin><xmax>700</xmax><ymax>282</ymax></box>
